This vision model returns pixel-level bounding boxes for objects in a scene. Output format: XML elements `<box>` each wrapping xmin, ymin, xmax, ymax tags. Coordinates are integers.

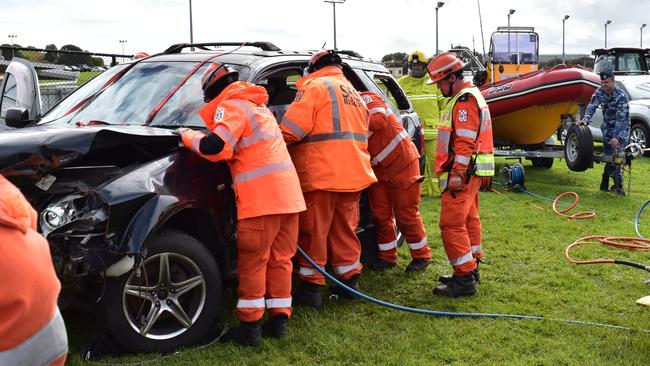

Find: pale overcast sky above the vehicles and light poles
<box><xmin>0</xmin><ymin>0</ymin><xmax>650</xmax><ymax>60</ymax></box>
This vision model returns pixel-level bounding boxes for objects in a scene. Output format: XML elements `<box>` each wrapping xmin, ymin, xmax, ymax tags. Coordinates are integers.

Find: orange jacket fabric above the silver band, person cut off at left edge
<box><xmin>0</xmin><ymin>176</ymin><xmax>61</xmax><ymax>352</ymax></box>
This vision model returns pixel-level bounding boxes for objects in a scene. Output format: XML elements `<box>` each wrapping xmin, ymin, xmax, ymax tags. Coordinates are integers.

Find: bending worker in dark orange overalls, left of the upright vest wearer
<box><xmin>361</xmin><ymin>91</ymin><xmax>431</xmax><ymax>272</ymax></box>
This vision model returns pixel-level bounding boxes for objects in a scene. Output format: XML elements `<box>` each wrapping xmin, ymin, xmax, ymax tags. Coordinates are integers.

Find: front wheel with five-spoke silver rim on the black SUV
<box><xmin>99</xmin><ymin>230</ymin><xmax>223</xmax><ymax>352</ymax></box>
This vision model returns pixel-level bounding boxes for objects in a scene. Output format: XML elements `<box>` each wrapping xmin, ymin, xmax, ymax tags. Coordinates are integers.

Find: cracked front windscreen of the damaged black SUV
<box><xmin>41</xmin><ymin>61</ymin><xmax>248</xmax><ymax>126</ymax></box>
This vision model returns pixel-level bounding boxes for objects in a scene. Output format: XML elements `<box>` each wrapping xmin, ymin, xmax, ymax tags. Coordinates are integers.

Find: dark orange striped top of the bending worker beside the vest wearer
<box><xmin>361</xmin><ymin>92</ymin><xmax>421</xmax><ymax>182</ymax></box>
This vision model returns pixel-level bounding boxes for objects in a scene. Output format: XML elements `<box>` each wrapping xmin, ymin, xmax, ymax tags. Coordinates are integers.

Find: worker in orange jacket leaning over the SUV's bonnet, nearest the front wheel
<box><xmin>181</xmin><ymin>63</ymin><xmax>305</xmax><ymax>345</ymax></box>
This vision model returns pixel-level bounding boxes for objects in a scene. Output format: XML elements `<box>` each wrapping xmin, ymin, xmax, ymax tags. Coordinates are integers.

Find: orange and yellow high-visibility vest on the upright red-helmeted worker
<box><xmin>436</xmin><ymin>87</ymin><xmax>494</xmax><ymax>190</ymax></box>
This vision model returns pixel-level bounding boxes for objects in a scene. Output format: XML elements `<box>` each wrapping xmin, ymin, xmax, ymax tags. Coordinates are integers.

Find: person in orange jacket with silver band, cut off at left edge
<box><xmin>0</xmin><ymin>175</ymin><xmax>68</xmax><ymax>366</ymax></box>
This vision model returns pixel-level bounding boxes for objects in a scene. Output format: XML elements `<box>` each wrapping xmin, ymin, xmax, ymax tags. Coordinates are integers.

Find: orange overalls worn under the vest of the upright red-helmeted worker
<box><xmin>436</xmin><ymin>83</ymin><xmax>492</xmax><ymax>276</ymax></box>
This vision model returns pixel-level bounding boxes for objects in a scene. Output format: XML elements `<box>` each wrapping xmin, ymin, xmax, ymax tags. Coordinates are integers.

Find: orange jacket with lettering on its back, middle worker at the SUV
<box><xmin>280</xmin><ymin>66</ymin><xmax>377</xmax><ymax>192</ymax></box>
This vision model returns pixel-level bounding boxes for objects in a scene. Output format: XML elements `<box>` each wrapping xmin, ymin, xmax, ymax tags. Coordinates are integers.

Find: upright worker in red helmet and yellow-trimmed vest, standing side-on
<box><xmin>427</xmin><ymin>52</ymin><xmax>494</xmax><ymax>297</ymax></box>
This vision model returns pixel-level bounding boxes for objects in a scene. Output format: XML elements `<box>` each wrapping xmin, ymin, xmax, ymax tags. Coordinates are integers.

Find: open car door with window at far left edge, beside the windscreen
<box><xmin>0</xmin><ymin>57</ymin><xmax>41</xmax><ymax>129</ymax></box>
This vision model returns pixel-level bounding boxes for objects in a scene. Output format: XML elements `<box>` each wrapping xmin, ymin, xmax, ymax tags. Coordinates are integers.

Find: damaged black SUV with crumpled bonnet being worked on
<box><xmin>0</xmin><ymin>42</ymin><xmax>420</xmax><ymax>352</ymax></box>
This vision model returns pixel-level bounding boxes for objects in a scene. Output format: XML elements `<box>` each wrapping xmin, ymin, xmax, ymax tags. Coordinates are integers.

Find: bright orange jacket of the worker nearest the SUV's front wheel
<box><xmin>192</xmin><ymin>81</ymin><xmax>305</xmax><ymax>219</ymax></box>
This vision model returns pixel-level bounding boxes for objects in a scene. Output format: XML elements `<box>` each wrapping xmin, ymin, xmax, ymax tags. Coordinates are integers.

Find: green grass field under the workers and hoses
<box><xmin>63</xmin><ymin>158</ymin><xmax>650</xmax><ymax>365</ymax></box>
